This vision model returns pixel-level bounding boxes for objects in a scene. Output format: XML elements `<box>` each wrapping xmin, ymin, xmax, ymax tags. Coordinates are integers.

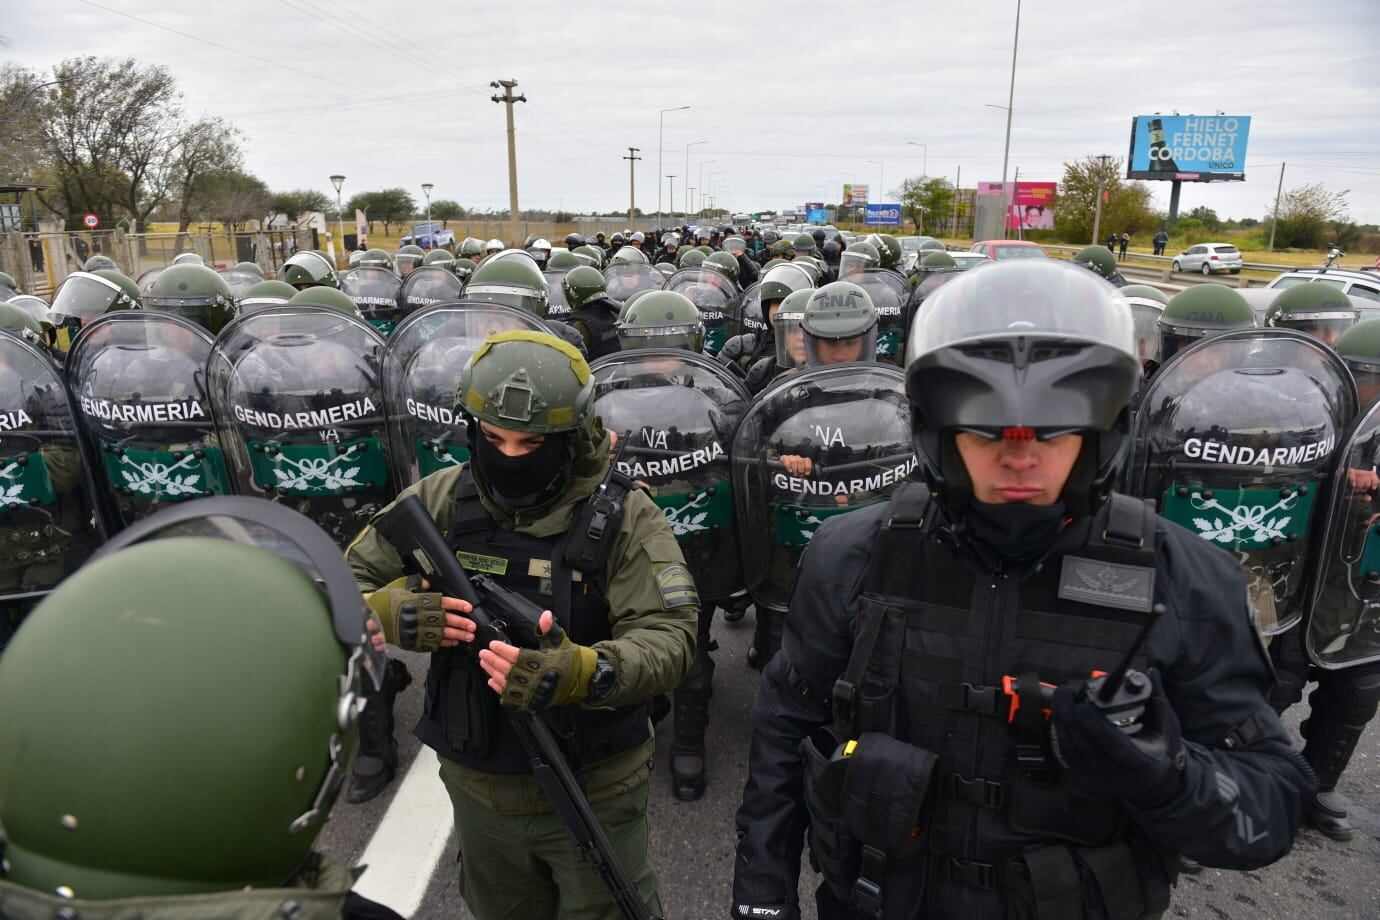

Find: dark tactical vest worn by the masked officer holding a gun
<box><xmin>417</xmin><ymin>470</ymin><xmax>650</xmax><ymax>774</ymax></box>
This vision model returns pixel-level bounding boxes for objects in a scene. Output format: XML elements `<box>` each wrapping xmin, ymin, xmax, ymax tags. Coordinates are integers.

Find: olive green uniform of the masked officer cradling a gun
<box><xmin>345</xmin><ymin>432</ymin><xmax>698</xmax><ymax>919</ymax></box>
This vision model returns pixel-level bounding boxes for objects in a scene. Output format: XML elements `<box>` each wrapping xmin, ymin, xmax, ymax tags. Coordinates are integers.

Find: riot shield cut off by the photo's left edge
<box><xmin>0</xmin><ymin>331</ymin><xmax>105</xmax><ymax>628</ymax></box>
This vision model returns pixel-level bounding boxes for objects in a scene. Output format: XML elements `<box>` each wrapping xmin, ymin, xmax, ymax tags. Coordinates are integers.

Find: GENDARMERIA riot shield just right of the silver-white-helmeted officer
<box><xmin>1127</xmin><ymin>328</ymin><xmax>1357</xmax><ymax>636</ymax></box>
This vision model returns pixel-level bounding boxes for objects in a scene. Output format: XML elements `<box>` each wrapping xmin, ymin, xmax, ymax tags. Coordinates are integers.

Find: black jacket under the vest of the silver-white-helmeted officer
<box><xmin>733</xmin><ymin>503</ymin><xmax>1312</xmax><ymax>917</ymax></box>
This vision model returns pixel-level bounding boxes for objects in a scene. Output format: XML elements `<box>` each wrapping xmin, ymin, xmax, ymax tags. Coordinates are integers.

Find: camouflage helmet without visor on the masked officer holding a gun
<box><xmin>455</xmin><ymin>331</ymin><xmax>595</xmax><ymax>441</ymax></box>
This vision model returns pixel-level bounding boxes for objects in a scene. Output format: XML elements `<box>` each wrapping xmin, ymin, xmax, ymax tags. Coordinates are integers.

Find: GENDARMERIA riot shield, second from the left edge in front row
<box><xmin>68</xmin><ymin>310</ymin><xmax>230</xmax><ymax>527</ymax></box>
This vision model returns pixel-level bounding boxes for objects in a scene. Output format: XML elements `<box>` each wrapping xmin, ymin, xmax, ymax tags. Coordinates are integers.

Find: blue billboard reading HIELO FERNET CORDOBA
<box><xmin>1126</xmin><ymin>114</ymin><xmax>1250</xmax><ymax>182</ymax></box>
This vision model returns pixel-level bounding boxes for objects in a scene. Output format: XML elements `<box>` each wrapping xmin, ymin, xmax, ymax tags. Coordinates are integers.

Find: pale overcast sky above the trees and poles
<box><xmin>0</xmin><ymin>0</ymin><xmax>1380</xmax><ymax>222</ymax></box>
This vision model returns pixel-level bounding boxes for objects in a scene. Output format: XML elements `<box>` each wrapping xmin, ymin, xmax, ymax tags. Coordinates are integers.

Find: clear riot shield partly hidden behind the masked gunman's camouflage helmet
<box><xmin>384</xmin><ymin>303</ymin><xmax>546</xmax><ymax>490</ymax></box>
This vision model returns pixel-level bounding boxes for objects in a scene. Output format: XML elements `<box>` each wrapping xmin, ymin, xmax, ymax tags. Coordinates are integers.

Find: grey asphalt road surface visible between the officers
<box><xmin>320</xmin><ymin>612</ymin><xmax>1380</xmax><ymax>920</ymax></box>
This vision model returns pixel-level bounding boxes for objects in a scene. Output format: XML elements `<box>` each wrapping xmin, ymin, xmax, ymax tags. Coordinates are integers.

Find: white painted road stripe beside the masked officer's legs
<box><xmin>355</xmin><ymin>748</ymin><xmax>455</xmax><ymax>917</ymax></box>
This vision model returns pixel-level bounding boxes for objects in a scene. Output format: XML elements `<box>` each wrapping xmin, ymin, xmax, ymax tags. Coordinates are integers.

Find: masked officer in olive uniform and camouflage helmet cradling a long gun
<box><xmin>346</xmin><ymin>331</ymin><xmax>698</xmax><ymax>919</ymax></box>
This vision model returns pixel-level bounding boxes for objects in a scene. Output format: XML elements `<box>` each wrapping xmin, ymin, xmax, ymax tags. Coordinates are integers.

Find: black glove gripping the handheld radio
<box><xmin>1049</xmin><ymin>668</ymin><xmax>1185</xmax><ymax>807</ymax></box>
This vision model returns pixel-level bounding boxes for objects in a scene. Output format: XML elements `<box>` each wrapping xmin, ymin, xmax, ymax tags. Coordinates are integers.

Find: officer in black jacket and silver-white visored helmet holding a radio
<box><xmin>733</xmin><ymin>261</ymin><xmax>1311</xmax><ymax>917</ymax></box>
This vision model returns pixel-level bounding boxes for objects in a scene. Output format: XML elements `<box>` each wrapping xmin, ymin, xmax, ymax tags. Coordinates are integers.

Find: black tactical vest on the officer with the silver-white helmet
<box><xmin>807</xmin><ymin>484</ymin><xmax>1177</xmax><ymax>920</ymax></box>
